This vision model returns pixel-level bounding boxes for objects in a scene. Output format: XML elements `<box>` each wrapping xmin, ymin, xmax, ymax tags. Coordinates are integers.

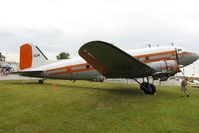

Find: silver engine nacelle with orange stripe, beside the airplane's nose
<box><xmin>147</xmin><ymin>60</ymin><xmax>179</xmax><ymax>81</ymax></box>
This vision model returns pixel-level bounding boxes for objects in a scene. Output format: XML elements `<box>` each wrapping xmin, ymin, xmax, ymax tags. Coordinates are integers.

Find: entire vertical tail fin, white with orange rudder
<box><xmin>19</xmin><ymin>44</ymin><xmax>48</xmax><ymax>70</ymax></box>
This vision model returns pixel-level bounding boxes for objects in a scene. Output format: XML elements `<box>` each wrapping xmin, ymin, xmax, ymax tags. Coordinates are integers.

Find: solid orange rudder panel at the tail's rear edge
<box><xmin>19</xmin><ymin>44</ymin><xmax>32</xmax><ymax>70</ymax></box>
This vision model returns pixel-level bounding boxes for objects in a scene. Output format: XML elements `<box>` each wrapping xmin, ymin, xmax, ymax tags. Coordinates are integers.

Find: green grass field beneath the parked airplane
<box><xmin>0</xmin><ymin>80</ymin><xmax>199</xmax><ymax>133</ymax></box>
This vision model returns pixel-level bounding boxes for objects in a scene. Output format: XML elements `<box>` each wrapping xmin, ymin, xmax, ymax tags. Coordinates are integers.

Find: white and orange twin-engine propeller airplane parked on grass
<box><xmin>16</xmin><ymin>41</ymin><xmax>199</xmax><ymax>95</ymax></box>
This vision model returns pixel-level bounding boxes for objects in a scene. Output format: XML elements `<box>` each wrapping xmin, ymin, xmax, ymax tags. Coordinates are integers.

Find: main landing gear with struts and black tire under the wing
<box><xmin>134</xmin><ymin>77</ymin><xmax>156</xmax><ymax>95</ymax></box>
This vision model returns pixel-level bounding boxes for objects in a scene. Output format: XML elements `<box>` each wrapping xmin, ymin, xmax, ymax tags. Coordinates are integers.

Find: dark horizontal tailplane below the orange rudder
<box><xmin>8</xmin><ymin>71</ymin><xmax>44</xmax><ymax>77</ymax></box>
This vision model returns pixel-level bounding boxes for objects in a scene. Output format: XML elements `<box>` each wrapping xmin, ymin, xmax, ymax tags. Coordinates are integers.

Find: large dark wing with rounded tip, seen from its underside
<box><xmin>79</xmin><ymin>41</ymin><xmax>154</xmax><ymax>78</ymax></box>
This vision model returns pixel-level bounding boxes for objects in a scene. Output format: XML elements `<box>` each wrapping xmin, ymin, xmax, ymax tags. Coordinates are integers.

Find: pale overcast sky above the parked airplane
<box><xmin>0</xmin><ymin>0</ymin><xmax>199</xmax><ymax>76</ymax></box>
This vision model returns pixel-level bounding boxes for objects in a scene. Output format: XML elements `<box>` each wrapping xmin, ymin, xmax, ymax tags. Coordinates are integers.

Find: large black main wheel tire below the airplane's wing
<box><xmin>140</xmin><ymin>82</ymin><xmax>156</xmax><ymax>95</ymax></box>
